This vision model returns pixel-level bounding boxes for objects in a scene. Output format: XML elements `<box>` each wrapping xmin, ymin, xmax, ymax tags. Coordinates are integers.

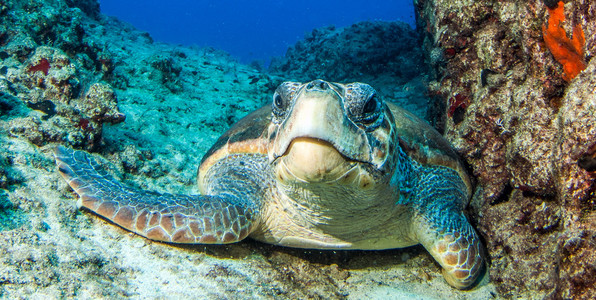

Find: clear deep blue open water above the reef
<box><xmin>100</xmin><ymin>0</ymin><xmax>414</xmax><ymax>63</ymax></box>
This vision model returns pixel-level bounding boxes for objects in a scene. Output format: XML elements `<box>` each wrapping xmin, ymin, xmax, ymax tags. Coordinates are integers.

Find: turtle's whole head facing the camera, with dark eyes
<box><xmin>268</xmin><ymin>80</ymin><xmax>397</xmax><ymax>187</ymax></box>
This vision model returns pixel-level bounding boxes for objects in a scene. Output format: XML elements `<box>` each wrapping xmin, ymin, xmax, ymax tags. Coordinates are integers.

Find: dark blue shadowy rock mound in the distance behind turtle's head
<box><xmin>269</xmin><ymin>21</ymin><xmax>428</xmax><ymax>118</ymax></box>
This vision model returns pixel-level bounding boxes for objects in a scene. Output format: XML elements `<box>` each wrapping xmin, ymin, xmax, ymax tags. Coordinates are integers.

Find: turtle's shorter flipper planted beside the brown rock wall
<box><xmin>412</xmin><ymin>167</ymin><xmax>485</xmax><ymax>289</ymax></box>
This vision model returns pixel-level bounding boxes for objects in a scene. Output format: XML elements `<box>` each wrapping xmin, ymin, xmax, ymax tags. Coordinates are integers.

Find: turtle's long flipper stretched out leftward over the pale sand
<box><xmin>54</xmin><ymin>146</ymin><xmax>258</xmax><ymax>244</ymax></box>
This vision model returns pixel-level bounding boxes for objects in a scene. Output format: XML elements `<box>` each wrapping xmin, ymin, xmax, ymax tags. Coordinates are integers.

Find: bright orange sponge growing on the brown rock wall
<box><xmin>542</xmin><ymin>1</ymin><xmax>586</xmax><ymax>81</ymax></box>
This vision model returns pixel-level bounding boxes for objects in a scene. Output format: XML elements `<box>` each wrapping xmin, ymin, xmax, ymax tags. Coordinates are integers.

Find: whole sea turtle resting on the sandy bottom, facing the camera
<box><xmin>55</xmin><ymin>80</ymin><xmax>484</xmax><ymax>289</ymax></box>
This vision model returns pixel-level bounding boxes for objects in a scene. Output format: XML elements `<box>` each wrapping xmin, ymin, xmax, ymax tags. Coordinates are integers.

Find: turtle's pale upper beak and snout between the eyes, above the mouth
<box><xmin>269</xmin><ymin>80</ymin><xmax>371</xmax><ymax>162</ymax></box>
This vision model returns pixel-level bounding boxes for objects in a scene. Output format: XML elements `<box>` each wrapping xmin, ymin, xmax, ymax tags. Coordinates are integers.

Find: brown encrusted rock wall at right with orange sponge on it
<box><xmin>415</xmin><ymin>0</ymin><xmax>596</xmax><ymax>299</ymax></box>
